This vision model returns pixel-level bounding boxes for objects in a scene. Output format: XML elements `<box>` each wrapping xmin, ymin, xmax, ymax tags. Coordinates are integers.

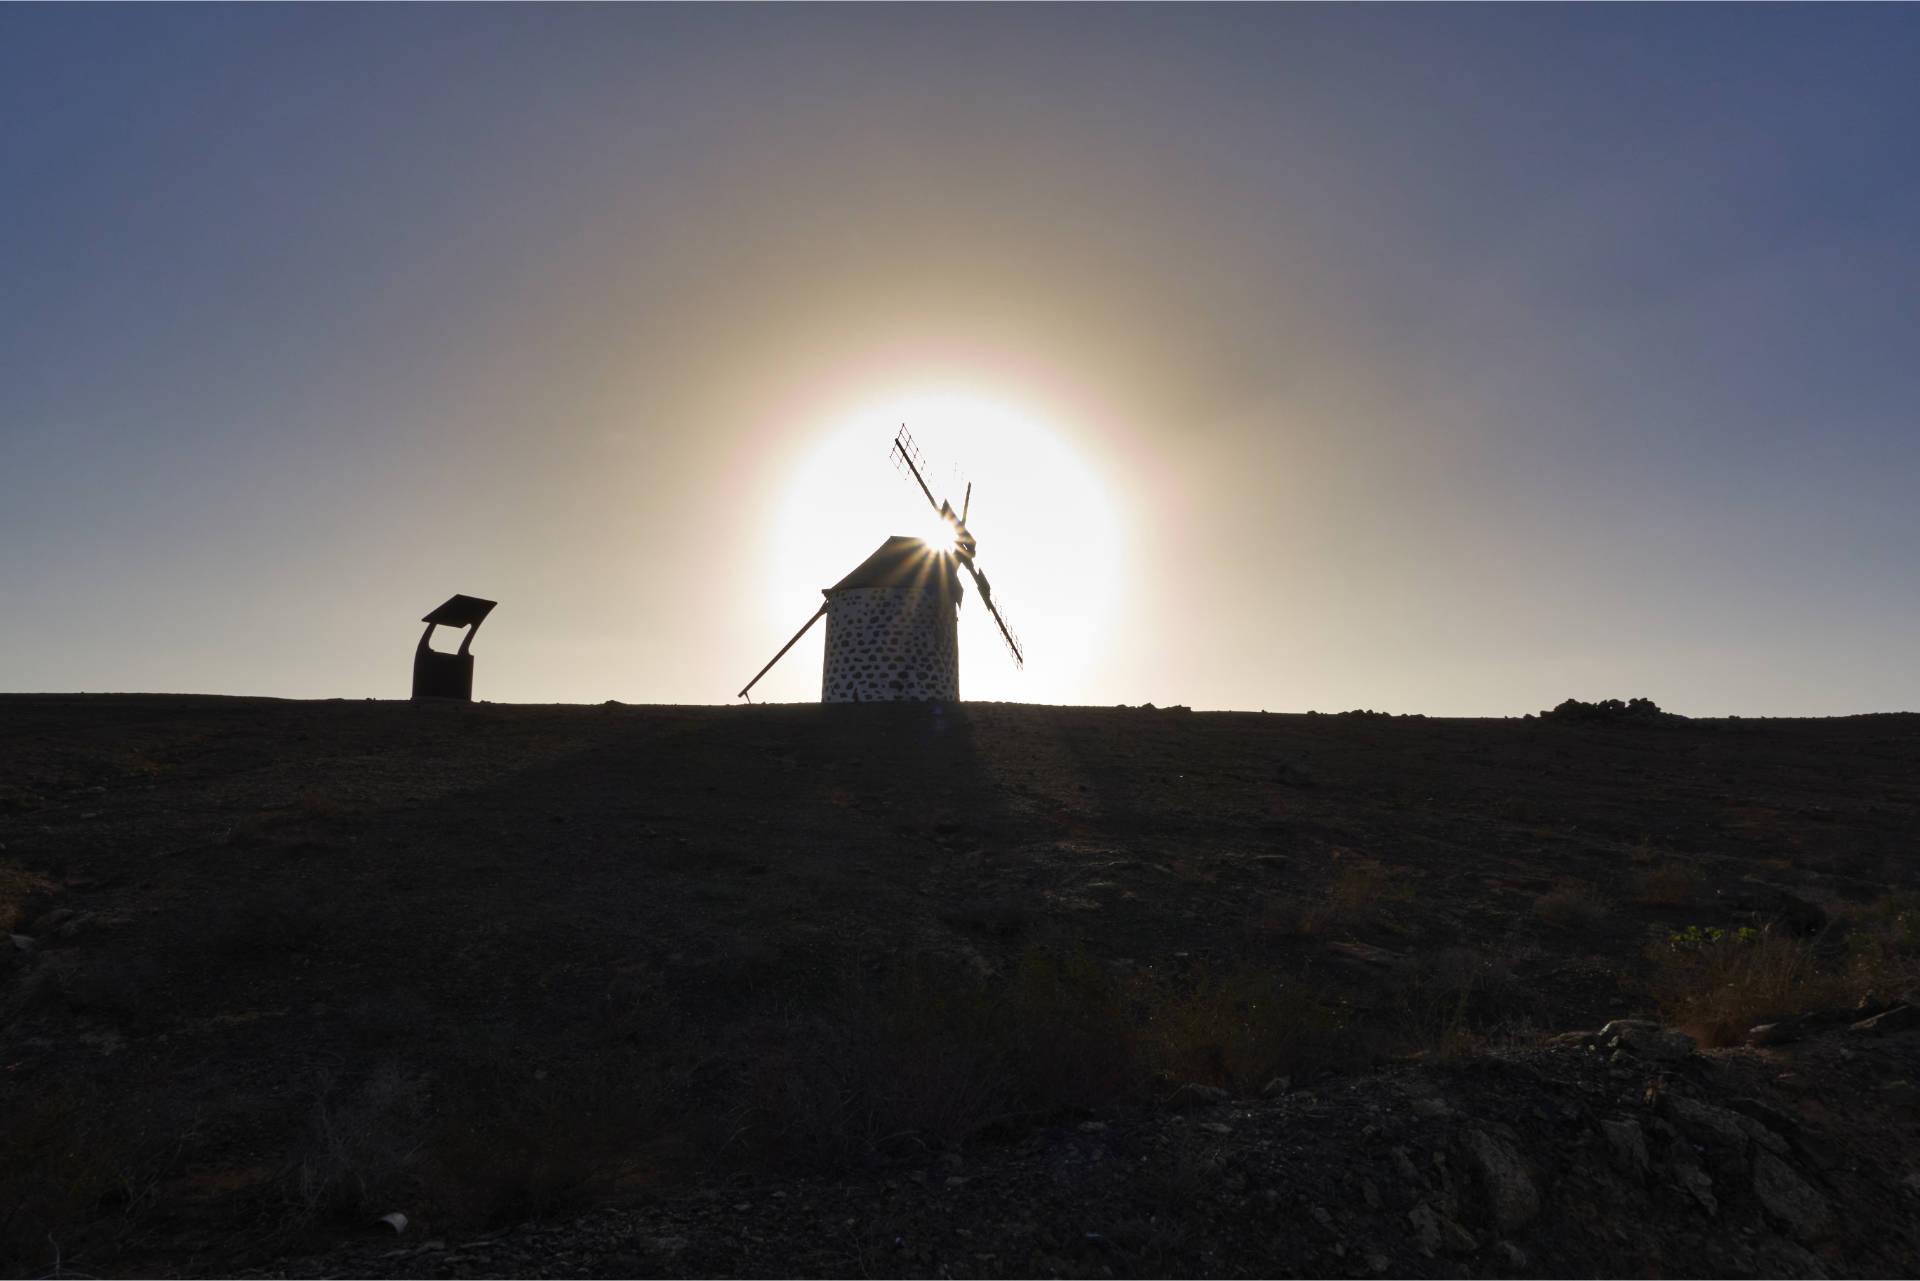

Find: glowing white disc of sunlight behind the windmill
<box><xmin>762</xmin><ymin>388</ymin><xmax>1131</xmax><ymax>703</ymax></box>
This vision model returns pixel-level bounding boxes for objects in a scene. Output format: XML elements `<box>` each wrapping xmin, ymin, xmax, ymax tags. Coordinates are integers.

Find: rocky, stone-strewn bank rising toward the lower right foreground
<box><xmin>250</xmin><ymin>1006</ymin><xmax>1920</xmax><ymax>1277</ymax></box>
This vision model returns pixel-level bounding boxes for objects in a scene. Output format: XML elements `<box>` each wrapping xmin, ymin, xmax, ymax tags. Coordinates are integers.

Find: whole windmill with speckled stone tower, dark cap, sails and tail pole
<box><xmin>739</xmin><ymin>426</ymin><xmax>1025</xmax><ymax>703</ymax></box>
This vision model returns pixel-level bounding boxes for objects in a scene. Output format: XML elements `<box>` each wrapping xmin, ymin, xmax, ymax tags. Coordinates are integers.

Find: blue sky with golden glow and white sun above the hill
<box><xmin>0</xmin><ymin>4</ymin><xmax>1920</xmax><ymax>716</ymax></box>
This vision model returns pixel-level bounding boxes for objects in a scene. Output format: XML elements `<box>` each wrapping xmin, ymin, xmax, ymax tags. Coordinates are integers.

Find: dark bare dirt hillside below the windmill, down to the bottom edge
<box><xmin>0</xmin><ymin>695</ymin><xmax>1920</xmax><ymax>1275</ymax></box>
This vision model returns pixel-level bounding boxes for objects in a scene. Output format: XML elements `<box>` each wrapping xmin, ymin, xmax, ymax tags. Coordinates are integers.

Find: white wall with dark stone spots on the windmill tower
<box><xmin>820</xmin><ymin>588</ymin><xmax>960</xmax><ymax>703</ymax></box>
